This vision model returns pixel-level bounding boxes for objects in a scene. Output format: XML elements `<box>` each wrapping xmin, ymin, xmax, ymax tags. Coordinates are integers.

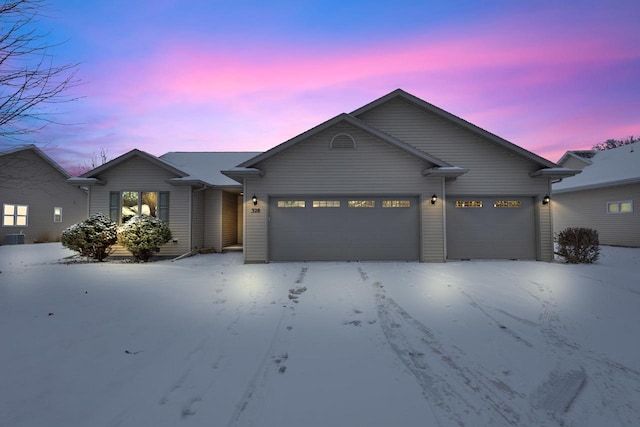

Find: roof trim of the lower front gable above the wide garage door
<box><xmin>238</xmin><ymin>113</ymin><xmax>453</xmax><ymax>168</ymax></box>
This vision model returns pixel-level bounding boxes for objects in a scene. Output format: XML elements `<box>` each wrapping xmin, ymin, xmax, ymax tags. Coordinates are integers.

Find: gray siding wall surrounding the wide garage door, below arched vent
<box><xmin>244</xmin><ymin>123</ymin><xmax>444</xmax><ymax>262</ymax></box>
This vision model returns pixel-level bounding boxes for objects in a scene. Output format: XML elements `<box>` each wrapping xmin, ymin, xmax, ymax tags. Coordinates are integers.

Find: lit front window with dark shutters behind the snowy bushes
<box><xmin>109</xmin><ymin>191</ymin><xmax>169</xmax><ymax>223</ymax></box>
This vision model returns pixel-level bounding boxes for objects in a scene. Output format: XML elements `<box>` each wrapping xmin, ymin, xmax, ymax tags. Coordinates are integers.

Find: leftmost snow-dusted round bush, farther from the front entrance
<box><xmin>60</xmin><ymin>212</ymin><xmax>118</xmax><ymax>261</ymax></box>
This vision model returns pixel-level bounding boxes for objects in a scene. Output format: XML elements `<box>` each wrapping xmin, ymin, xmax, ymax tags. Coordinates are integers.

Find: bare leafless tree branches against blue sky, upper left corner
<box><xmin>0</xmin><ymin>0</ymin><xmax>79</xmax><ymax>147</ymax></box>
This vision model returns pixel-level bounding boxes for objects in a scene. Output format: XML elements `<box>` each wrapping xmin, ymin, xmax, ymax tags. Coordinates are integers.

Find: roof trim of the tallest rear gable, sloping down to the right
<box><xmin>351</xmin><ymin>89</ymin><xmax>558</xmax><ymax>168</ymax></box>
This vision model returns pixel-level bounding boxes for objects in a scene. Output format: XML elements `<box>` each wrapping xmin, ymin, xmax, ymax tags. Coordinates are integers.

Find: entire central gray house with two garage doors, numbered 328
<box><xmin>69</xmin><ymin>90</ymin><xmax>577</xmax><ymax>263</ymax></box>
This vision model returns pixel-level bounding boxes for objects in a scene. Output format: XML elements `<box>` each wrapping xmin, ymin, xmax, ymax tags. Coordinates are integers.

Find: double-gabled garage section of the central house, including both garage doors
<box><xmin>223</xmin><ymin>90</ymin><xmax>577</xmax><ymax>263</ymax></box>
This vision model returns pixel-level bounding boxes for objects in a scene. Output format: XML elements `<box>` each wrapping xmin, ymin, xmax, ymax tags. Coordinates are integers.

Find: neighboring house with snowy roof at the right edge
<box><xmin>552</xmin><ymin>142</ymin><xmax>640</xmax><ymax>247</ymax></box>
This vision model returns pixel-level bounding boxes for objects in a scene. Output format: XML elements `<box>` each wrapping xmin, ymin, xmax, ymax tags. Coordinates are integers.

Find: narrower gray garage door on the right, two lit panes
<box><xmin>447</xmin><ymin>196</ymin><xmax>536</xmax><ymax>259</ymax></box>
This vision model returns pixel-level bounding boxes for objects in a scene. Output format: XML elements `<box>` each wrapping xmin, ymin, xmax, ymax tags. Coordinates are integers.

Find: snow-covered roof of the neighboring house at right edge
<box><xmin>553</xmin><ymin>142</ymin><xmax>640</xmax><ymax>193</ymax></box>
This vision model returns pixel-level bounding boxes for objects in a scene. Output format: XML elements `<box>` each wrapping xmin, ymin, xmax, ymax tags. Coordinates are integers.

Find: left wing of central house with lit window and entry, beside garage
<box><xmin>67</xmin><ymin>150</ymin><xmax>258</xmax><ymax>256</ymax></box>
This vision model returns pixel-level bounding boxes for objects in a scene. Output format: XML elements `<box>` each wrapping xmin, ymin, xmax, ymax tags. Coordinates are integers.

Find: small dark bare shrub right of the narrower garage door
<box><xmin>558</xmin><ymin>227</ymin><xmax>600</xmax><ymax>264</ymax></box>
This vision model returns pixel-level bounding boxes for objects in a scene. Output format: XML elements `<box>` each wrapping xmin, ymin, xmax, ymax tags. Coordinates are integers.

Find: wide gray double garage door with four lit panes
<box><xmin>269</xmin><ymin>196</ymin><xmax>419</xmax><ymax>261</ymax></box>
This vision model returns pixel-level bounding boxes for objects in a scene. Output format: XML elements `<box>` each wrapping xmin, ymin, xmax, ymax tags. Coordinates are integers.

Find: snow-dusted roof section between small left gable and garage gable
<box><xmin>160</xmin><ymin>151</ymin><xmax>260</xmax><ymax>187</ymax></box>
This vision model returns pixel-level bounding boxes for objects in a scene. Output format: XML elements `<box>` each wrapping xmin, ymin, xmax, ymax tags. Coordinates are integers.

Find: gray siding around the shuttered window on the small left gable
<box><xmin>89</xmin><ymin>157</ymin><xmax>191</xmax><ymax>256</ymax></box>
